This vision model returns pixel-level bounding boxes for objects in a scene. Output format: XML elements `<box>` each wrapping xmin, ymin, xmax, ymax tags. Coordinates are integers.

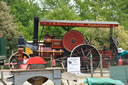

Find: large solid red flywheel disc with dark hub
<box><xmin>63</xmin><ymin>30</ymin><xmax>85</xmax><ymax>52</ymax></box>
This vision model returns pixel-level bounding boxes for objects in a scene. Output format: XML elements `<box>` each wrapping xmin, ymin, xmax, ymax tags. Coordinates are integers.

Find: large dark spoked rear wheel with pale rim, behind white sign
<box><xmin>70</xmin><ymin>45</ymin><xmax>100</xmax><ymax>73</ymax></box>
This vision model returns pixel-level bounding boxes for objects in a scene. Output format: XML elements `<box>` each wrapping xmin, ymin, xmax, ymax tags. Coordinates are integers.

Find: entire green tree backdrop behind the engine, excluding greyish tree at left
<box><xmin>1</xmin><ymin>0</ymin><xmax>128</xmax><ymax>49</ymax></box>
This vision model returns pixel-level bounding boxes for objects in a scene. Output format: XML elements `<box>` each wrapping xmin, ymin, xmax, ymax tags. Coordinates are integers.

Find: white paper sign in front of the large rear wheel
<box><xmin>67</xmin><ymin>57</ymin><xmax>80</xmax><ymax>74</ymax></box>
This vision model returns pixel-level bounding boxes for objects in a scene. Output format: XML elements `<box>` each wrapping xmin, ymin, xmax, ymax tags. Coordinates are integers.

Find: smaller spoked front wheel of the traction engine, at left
<box><xmin>9</xmin><ymin>52</ymin><xmax>30</xmax><ymax>69</ymax></box>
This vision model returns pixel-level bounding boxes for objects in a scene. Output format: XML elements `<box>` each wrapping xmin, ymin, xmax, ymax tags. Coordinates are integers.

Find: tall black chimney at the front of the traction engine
<box><xmin>33</xmin><ymin>17</ymin><xmax>39</xmax><ymax>45</ymax></box>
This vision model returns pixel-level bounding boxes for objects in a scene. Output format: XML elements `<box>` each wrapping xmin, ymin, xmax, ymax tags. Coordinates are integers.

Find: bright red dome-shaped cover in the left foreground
<box><xmin>26</xmin><ymin>56</ymin><xmax>46</xmax><ymax>64</ymax></box>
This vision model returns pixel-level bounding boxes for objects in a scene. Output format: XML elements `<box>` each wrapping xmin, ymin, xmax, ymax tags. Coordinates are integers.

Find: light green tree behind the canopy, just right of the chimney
<box><xmin>39</xmin><ymin>0</ymin><xmax>80</xmax><ymax>37</ymax></box>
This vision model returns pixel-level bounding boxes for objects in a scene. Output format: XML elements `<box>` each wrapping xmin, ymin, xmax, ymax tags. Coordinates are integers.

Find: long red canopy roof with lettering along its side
<box><xmin>40</xmin><ymin>20</ymin><xmax>118</xmax><ymax>28</ymax></box>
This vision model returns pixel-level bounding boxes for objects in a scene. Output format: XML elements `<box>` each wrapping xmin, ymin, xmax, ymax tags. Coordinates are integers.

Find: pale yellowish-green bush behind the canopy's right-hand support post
<box><xmin>84</xmin><ymin>26</ymin><xmax>128</xmax><ymax>50</ymax></box>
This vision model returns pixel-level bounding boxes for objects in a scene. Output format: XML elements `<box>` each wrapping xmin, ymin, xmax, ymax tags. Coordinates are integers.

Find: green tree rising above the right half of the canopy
<box><xmin>74</xmin><ymin>0</ymin><xmax>128</xmax><ymax>28</ymax></box>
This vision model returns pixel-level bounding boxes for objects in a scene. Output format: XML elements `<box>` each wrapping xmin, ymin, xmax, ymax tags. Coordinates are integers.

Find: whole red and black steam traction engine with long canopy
<box><xmin>9</xmin><ymin>18</ymin><xmax>118</xmax><ymax>73</ymax></box>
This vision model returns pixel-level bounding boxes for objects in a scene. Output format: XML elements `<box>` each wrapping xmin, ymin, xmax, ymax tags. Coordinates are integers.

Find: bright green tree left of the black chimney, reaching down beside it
<box><xmin>4</xmin><ymin>0</ymin><xmax>42</xmax><ymax>40</ymax></box>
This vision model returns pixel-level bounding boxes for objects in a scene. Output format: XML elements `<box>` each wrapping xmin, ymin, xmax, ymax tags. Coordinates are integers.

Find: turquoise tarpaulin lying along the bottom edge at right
<box><xmin>84</xmin><ymin>78</ymin><xmax>125</xmax><ymax>85</ymax></box>
